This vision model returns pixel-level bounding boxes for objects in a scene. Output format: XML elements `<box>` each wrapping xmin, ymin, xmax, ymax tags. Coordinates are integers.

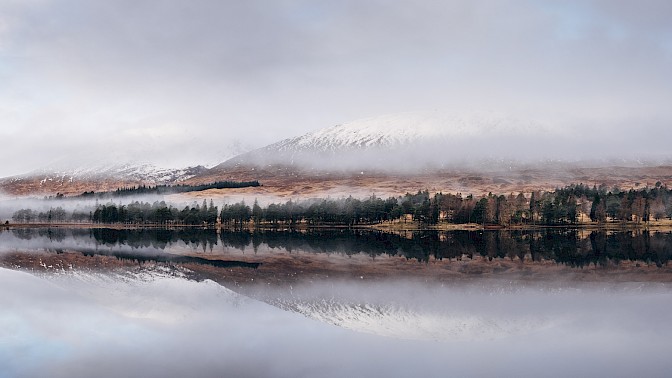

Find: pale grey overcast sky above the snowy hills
<box><xmin>0</xmin><ymin>0</ymin><xmax>672</xmax><ymax>177</ymax></box>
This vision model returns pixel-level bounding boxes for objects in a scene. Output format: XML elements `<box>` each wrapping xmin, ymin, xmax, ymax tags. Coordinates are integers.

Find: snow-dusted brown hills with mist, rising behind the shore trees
<box><xmin>0</xmin><ymin>111</ymin><xmax>672</xmax><ymax>196</ymax></box>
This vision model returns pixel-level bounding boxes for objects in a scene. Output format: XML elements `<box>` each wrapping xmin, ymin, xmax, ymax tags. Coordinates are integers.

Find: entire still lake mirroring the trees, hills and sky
<box><xmin>0</xmin><ymin>228</ymin><xmax>672</xmax><ymax>377</ymax></box>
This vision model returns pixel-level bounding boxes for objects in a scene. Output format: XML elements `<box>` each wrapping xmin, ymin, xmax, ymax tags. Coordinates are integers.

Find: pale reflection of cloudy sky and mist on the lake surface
<box><xmin>0</xmin><ymin>269</ymin><xmax>672</xmax><ymax>377</ymax></box>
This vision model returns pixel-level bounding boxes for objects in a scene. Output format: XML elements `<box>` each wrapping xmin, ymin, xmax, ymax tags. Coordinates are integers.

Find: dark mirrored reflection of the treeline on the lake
<box><xmin>0</xmin><ymin>228</ymin><xmax>672</xmax><ymax>267</ymax></box>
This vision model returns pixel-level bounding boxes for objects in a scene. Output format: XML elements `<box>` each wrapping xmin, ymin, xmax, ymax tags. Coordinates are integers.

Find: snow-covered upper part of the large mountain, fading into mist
<box><xmin>216</xmin><ymin>111</ymin><xmax>571</xmax><ymax>171</ymax></box>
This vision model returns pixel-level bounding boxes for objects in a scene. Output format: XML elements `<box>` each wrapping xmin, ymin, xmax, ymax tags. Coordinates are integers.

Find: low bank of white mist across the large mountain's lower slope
<box><xmin>240</xmin><ymin>137</ymin><xmax>672</xmax><ymax>173</ymax></box>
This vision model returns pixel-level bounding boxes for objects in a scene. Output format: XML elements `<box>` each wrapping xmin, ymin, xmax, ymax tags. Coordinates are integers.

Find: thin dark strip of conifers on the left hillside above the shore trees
<box><xmin>79</xmin><ymin>180</ymin><xmax>261</xmax><ymax>197</ymax></box>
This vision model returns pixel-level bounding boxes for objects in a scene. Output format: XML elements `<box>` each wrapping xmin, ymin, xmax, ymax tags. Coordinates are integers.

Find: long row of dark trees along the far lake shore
<box><xmin>12</xmin><ymin>183</ymin><xmax>672</xmax><ymax>227</ymax></box>
